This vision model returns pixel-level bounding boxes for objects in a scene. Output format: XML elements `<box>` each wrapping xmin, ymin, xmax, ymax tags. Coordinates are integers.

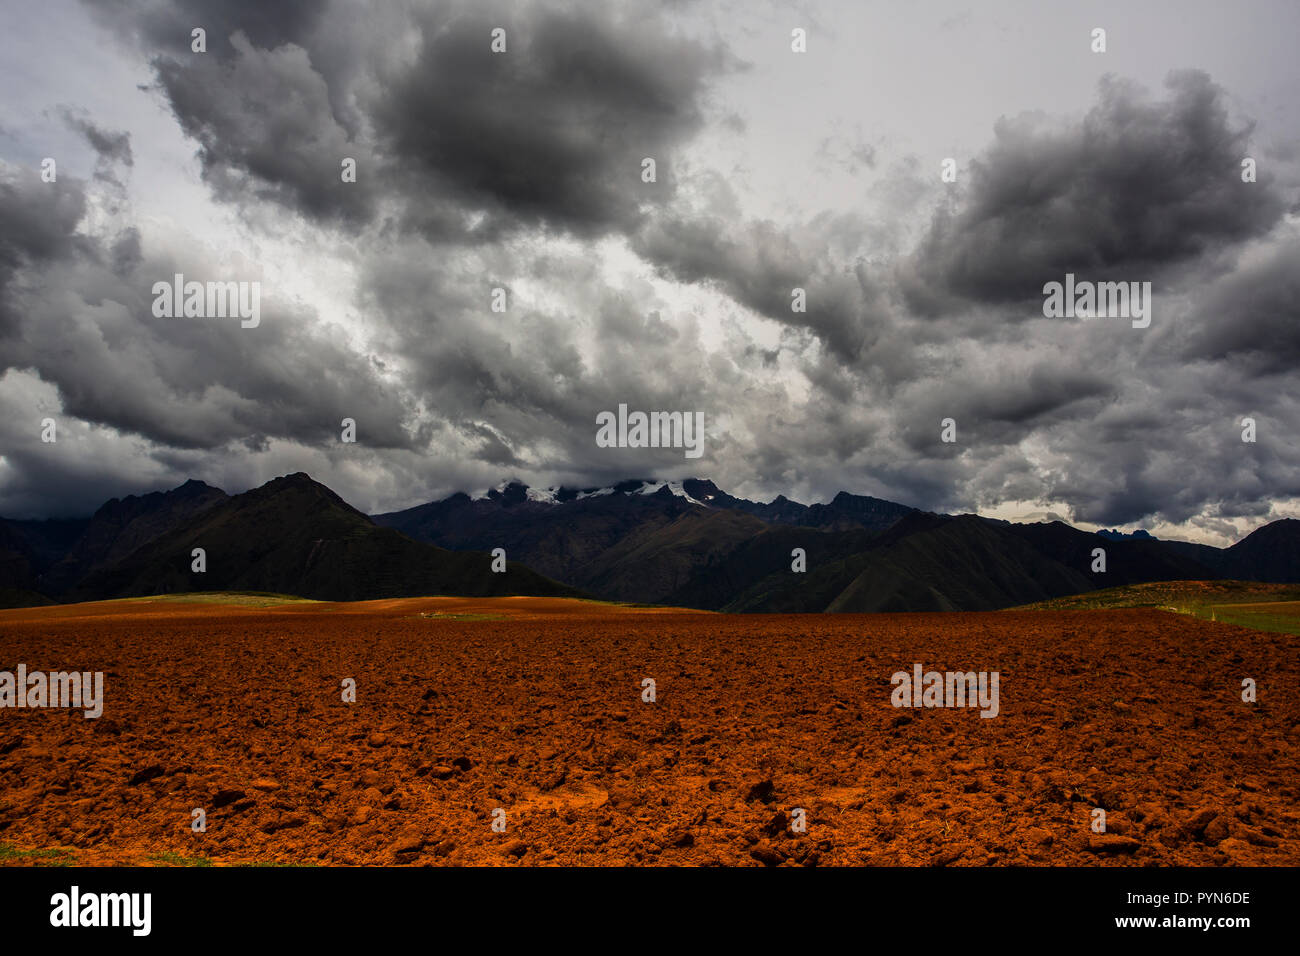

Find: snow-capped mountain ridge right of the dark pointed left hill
<box><xmin>374</xmin><ymin>479</ymin><xmax>1300</xmax><ymax>611</ymax></box>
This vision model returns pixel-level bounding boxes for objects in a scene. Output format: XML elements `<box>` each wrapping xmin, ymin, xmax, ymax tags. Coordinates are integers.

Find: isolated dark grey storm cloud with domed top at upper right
<box><xmin>901</xmin><ymin>72</ymin><xmax>1286</xmax><ymax>313</ymax></box>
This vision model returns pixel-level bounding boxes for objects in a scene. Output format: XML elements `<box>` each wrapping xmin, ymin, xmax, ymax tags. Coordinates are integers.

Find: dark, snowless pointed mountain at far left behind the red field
<box><xmin>0</xmin><ymin>473</ymin><xmax>580</xmax><ymax>606</ymax></box>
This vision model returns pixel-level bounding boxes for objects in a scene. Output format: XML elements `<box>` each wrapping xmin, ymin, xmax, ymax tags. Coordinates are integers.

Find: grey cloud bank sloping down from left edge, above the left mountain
<box><xmin>0</xmin><ymin>162</ymin><xmax>411</xmax><ymax>447</ymax></box>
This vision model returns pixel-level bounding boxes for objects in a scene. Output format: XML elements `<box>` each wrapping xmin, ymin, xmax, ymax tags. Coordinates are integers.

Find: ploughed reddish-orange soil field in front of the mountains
<box><xmin>0</xmin><ymin>598</ymin><xmax>1300</xmax><ymax>866</ymax></box>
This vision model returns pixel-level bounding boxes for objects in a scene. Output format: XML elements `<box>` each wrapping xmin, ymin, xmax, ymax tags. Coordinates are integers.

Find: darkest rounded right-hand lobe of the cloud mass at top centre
<box><xmin>374</xmin><ymin>5</ymin><xmax>727</xmax><ymax>235</ymax></box>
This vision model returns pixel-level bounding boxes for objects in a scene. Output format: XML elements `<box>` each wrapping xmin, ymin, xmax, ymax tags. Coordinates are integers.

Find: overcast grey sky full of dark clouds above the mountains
<box><xmin>0</xmin><ymin>0</ymin><xmax>1300</xmax><ymax>544</ymax></box>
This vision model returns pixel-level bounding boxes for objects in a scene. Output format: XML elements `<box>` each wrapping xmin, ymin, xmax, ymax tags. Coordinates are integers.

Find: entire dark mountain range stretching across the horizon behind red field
<box><xmin>0</xmin><ymin>473</ymin><xmax>1300</xmax><ymax>613</ymax></box>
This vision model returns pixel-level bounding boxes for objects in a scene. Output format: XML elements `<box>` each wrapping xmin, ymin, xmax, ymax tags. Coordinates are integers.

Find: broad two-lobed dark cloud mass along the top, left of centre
<box><xmin>122</xmin><ymin>3</ymin><xmax>735</xmax><ymax>242</ymax></box>
